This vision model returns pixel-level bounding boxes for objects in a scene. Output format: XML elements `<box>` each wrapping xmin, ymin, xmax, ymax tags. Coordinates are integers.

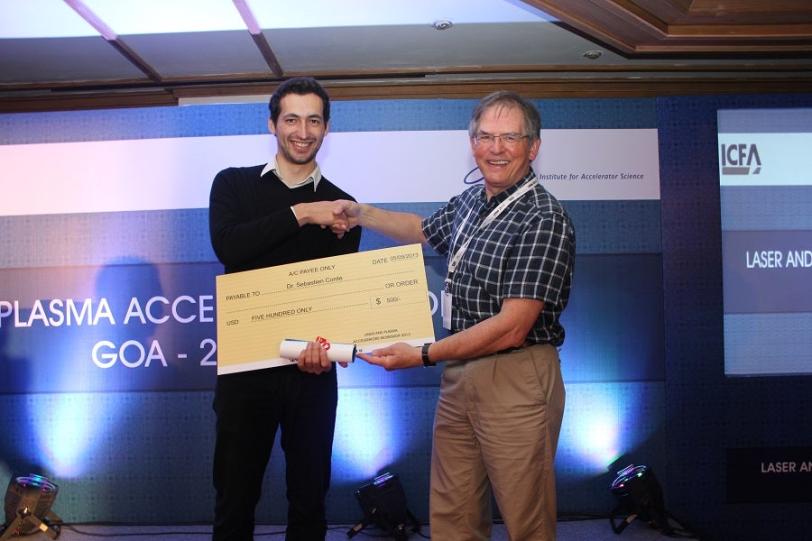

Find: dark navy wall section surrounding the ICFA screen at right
<box><xmin>656</xmin><ymin>94</ymin><xmax>812</xmax><ymax>541</ymax></box>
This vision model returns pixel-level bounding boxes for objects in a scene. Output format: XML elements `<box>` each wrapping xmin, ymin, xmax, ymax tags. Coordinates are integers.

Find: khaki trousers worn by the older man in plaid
<box><xmin>430</xmin><ymin>345</ymin><xmax>565</xmax><ymax>541</ymax></box>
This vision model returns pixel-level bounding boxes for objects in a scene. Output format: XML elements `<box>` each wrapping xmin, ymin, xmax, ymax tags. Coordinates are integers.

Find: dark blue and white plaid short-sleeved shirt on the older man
<box><xmin>422</xmin><ymin>170</ymin><xmax>575</xmax><ymax>346</ymax></box>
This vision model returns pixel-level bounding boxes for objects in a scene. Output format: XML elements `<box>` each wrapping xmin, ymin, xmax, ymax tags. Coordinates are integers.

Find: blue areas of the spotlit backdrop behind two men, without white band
<box><xmin>0</xmin><ymin>95</ymin><xmax>667</xmax><ymax>523</ymax></box>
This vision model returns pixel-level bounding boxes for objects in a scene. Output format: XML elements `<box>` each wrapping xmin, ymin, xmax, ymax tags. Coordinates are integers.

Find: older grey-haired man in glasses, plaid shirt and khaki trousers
<box><xmin>333</xmin><ymin>92</ymin><xmax>575</xmax><ymax>541</ymax></box>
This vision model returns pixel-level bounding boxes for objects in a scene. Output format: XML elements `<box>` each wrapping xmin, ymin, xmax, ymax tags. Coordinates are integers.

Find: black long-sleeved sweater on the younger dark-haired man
<box><xmin>209</xmin><ymin>165</ymin><xmax>361</xmax><ymax>273</ymax></box>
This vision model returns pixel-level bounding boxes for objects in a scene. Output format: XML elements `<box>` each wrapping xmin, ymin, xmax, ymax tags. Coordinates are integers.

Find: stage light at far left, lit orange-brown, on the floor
<box><xmin>0</xmin><ymin>473</ymin><xmax>62</xmax><ymax>541</ymax></box>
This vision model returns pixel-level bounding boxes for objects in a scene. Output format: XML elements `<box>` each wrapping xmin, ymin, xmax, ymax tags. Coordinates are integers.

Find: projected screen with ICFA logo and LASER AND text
<box><xmin>719</xmin><ymin>109</ymin><xmax>812</xmax><ymax>376</ymax></box>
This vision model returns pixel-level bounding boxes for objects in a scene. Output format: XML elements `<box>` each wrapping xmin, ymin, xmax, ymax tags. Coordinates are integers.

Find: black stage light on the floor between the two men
<box><xmin>347</xmin><ymin>472</ymin><xmax>420</xmax><ymax>541</ymax></box>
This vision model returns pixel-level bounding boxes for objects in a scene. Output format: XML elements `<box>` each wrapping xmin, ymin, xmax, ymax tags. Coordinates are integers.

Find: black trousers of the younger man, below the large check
<box><xmin>212</xmin><ymin>366</ymin><xmax>338</xmax><ymax>541</ymax></box>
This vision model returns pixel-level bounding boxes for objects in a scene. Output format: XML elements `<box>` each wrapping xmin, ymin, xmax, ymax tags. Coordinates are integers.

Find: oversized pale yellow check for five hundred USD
<box><xmin>216</xmin><ymin>244</ymin><xmax>434</xmax><ymax>374</ymax></box>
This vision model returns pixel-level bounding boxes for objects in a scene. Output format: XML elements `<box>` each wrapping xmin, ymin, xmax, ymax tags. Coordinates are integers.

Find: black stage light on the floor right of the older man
<box><xmin>609</xmin><ymin>464</ymin><xmax>672</xmax><ymax>534</ymax></box>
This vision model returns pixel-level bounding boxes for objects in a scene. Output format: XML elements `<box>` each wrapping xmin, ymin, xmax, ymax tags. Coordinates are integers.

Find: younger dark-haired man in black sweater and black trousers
<box><xmin>209</xmin><ymin>78</ymin><xmax>361</xmax><ymax>541</ymax></box>
